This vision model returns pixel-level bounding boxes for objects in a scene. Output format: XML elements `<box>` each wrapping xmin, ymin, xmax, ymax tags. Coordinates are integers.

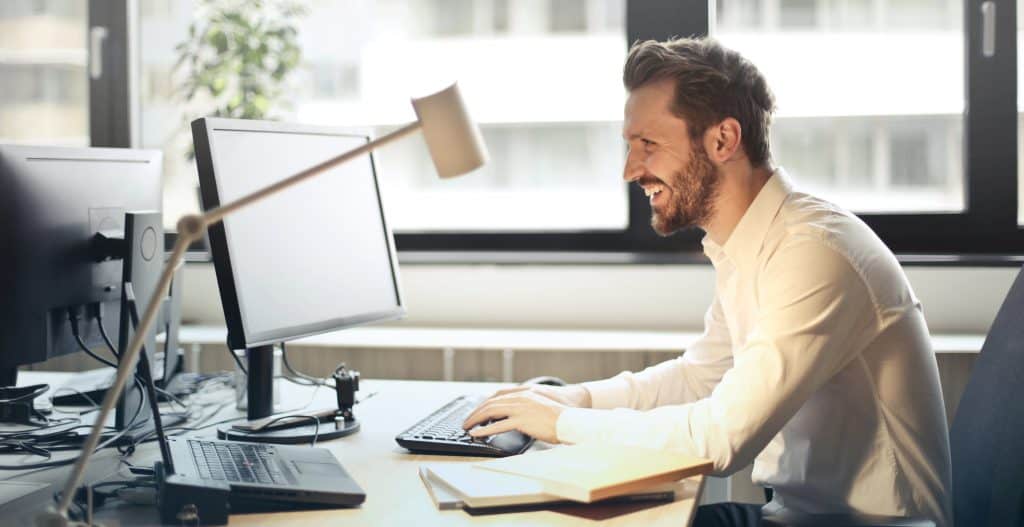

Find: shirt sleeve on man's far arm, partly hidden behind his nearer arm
<box><xmin>583</xmin><ymin>294</ymin><xmax>732</xmax><ymax>409</ymax></box>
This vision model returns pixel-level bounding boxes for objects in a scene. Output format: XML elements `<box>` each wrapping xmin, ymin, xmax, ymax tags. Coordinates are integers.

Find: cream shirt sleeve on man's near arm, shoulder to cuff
<box><xmin>557</xmin><ymin>236</ymin><xmax>880</xmax><ymax>474</ymax></box>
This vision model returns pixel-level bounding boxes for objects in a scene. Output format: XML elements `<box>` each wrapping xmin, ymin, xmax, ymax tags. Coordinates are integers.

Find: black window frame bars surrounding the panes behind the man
<box><xmin>108</xmin><ymin>0</ymin><xmax>1024</xmax><ymax>265</ymax></box>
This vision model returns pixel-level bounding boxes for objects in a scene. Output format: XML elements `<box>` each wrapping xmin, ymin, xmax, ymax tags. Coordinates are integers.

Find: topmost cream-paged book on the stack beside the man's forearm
<box><xmin>475</xmin><ymin>443</ymin><xmax>712</xmax><ymax>503</ymax></box>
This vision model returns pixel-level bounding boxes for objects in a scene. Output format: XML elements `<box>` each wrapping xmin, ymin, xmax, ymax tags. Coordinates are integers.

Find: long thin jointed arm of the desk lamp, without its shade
<box><xmin>46</xmin><ymin>121</ymin><xmax>421</xmax><ymax>525</ymax></box>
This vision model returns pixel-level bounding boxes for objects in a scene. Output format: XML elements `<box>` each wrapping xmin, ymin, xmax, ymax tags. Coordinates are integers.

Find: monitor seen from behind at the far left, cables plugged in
<box><xmin>0</xmin><ymin>145</ymin><xmax>163</xmax><ymax>437</ymax></box>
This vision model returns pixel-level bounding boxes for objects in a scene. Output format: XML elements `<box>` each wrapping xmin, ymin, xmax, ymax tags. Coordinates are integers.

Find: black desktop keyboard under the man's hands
<box><xmin>394</xmin><ymin>395</ymin><xmax>534</xmax><ymax>457</ymax></box>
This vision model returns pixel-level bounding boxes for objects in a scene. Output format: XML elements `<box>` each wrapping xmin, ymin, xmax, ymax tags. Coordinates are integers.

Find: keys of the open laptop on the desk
<box><xmin>188</xmin><ymin>440</ymin><xmax>289</xmax><ymax>485</ymax></box>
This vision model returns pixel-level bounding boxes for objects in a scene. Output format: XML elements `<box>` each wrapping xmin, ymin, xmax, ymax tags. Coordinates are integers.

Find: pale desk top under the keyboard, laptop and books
<box><xmin>6</xmin><ymin>371</ymin><xmax>703</xmax><ymax>527</ymax></box>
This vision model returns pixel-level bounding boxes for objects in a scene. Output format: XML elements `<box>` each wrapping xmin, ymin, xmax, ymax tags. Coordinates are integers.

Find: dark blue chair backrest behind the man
<box><xmin>949</xmin><ymin>270</ymin><xmax>1024</xmax><ymax>526</ymax></box>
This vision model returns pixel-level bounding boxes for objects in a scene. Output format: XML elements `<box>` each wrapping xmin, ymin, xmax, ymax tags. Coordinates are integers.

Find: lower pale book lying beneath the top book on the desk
<box><xmin>420</xmin><ymin>463</ymin><xmax>676</xmax><ymax>512</ymax></box>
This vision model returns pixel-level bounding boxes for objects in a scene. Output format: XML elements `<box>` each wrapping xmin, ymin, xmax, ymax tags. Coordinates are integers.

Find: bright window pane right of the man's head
<box><xmin>714</xmin><ymin>0</ymin><xmax>966</xmax><ymax>213</ymax></box>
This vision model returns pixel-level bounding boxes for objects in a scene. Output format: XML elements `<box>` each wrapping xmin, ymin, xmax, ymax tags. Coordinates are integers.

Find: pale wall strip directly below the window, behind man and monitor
<box><xmin>184</xmin><ymin>264</ymin><xmax>1018</xmax><ymax>334</ymax></box>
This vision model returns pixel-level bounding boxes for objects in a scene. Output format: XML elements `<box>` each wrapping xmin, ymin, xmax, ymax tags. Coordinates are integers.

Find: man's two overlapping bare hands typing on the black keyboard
<box><xmin>463</xmin><ymin>385</ymin><xmax>590</xmax><ymax>443</ymax></box>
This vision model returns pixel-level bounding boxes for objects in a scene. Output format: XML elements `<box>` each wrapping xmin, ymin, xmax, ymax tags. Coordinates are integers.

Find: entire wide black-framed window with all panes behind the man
<box><xmin>14</xmin><ymin>0</ymin><xmax>1007</xmax><ymax>261</ymax></box>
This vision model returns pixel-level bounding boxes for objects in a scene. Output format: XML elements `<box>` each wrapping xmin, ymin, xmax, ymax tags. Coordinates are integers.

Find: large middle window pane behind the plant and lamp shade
<box><xmin>139</xmin><ymin>0</ymin><xmax>628</xmax><ymax>233</ymax></box>
